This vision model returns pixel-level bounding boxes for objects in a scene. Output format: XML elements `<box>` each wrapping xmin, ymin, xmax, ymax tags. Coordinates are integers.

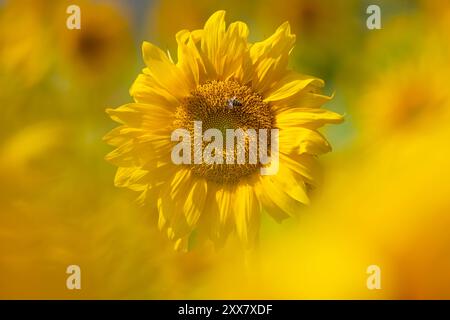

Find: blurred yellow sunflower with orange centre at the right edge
<box><xmin>359</xmin><ymin>55</ymin><xmax>450</xmax><ymax>141</ymax></box>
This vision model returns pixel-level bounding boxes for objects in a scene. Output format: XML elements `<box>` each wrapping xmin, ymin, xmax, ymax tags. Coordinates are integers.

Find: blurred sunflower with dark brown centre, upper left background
<box><xmin>54</xmin><ymin>1</ymin><xmax>133</xmax><ymax>87</ymax></box>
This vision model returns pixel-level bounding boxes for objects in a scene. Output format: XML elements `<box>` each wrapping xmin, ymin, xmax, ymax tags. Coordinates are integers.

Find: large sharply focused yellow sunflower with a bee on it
<box><xmin>105</xmin><ymin>11</ymin><xmax>343</xmax><ymax>250</ymax></box>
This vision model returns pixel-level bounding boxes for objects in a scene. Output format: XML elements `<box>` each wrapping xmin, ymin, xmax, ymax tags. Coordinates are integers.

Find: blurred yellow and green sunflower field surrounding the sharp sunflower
<box><xmin>0</xmin><ymin>0</ymin><xmax>450</xmax><ymax>299</ymax></box>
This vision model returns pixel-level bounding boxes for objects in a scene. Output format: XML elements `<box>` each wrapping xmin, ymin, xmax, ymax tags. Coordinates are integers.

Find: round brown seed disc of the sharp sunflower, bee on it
<box><xmin>174</xmin><ymin>81</ymin><xmax>275</xmax><ymax>184</ymax></box>
